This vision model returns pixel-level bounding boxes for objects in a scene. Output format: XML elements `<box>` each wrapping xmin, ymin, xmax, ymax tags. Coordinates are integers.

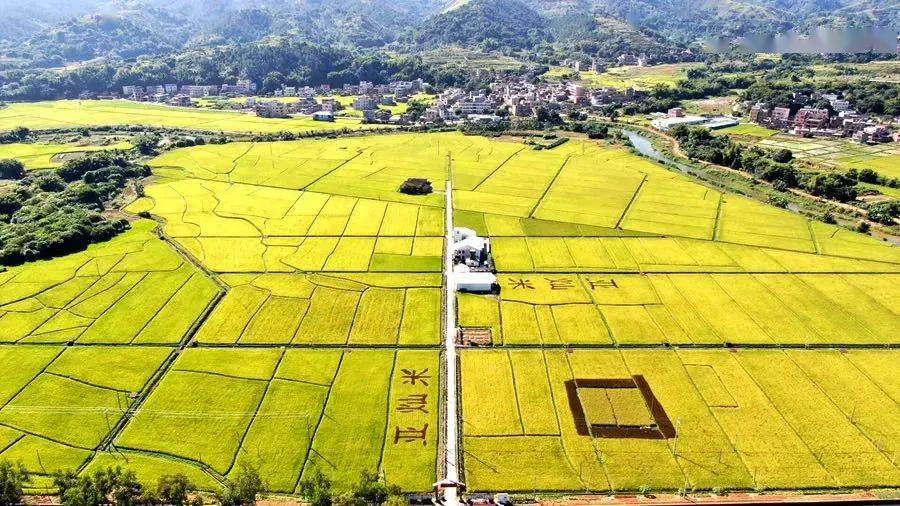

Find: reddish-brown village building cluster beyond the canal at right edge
<box><xmin>744</xmin><ymin>93</ymin><xmax>900</xmax><ymax>144</ymax></box>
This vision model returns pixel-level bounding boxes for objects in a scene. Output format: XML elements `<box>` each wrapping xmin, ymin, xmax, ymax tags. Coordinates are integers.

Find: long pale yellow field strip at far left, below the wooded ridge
<box><xmin>0</xmin><ymin>100</ymin><xmax>363</xmax><ymax>133</ymax></box>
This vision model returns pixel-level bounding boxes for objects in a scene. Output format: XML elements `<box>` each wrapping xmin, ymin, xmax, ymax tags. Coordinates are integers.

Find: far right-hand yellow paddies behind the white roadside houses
<box><xmin>451</xmin><ymin>132</ymin><xmax>900</xmax><ymax>262</ymax></box>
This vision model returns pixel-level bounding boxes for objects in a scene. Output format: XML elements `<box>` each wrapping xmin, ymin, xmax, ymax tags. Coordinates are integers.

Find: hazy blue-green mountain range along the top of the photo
<box><xmin>0</xmin><ymin>0</ymin><xmax>900</xmax><ymax>66</ymax></box>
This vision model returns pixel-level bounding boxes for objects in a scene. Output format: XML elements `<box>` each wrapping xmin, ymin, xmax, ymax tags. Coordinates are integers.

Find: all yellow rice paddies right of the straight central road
<box><xmin>452</xmin><ymin>133</ymin><xmax>900</xmax><ymax>492</ymax></box>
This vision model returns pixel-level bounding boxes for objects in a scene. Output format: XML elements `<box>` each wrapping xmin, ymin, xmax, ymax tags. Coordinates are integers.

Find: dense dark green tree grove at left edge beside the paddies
<box><xmin>0</xmin><ymin>152</ymin><xmax>150</xmax><ymax>265</ymax></box>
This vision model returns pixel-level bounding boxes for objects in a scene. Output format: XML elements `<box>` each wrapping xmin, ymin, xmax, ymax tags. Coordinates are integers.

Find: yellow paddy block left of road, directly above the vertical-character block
<box><xmin>197</xmin><ymin>274</ymin><xmax>441</xmax><ymax>346</ymax></box>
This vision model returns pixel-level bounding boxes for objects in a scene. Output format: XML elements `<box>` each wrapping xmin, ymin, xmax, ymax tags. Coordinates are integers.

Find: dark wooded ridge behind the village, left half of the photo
<box><xmin>0</xmin><ymin>39</ymin><xmax>450</xmax><ymax>100</ymax></box>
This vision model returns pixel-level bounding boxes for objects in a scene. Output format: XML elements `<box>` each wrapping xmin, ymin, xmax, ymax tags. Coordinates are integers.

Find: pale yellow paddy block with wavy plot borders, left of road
<box><xmin>130</xmin><ymin>179</ymin><xmax>443</xmax><ymax>272</ymax></box>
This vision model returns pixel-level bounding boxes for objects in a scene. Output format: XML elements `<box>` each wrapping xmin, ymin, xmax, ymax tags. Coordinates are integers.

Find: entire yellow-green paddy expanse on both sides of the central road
<box><xmin>0</xmin><ymin>133</ymin><xmax>900</xmax><ymax>494</ymax></box>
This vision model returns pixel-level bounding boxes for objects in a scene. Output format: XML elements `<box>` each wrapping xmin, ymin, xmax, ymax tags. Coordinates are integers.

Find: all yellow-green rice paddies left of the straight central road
<box><xmin>0</xmin><ymin>133</ymin><xmax>458</xmax><ymax>494</ymax></box>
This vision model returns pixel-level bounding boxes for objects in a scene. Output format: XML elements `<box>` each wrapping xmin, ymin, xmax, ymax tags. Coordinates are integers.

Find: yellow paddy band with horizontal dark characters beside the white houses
<box><xmin>458</xmin><ymin>273</ymin><xmax>900</xmax><ymax>346</ymax></box>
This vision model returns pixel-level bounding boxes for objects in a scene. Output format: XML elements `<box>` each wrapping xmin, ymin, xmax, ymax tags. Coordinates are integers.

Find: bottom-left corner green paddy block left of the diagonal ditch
<box><xmin>0</xmin><ymin>345</ymin><xmax>171</xmax><ymax>475</ymax></box>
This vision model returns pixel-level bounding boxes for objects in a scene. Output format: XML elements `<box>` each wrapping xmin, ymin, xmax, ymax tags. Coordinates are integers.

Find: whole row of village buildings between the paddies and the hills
<box><xmin>116</xmin><ymin>73</ymin><xmax>900</xmax><ymax>144</ymax></box>
